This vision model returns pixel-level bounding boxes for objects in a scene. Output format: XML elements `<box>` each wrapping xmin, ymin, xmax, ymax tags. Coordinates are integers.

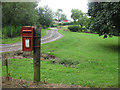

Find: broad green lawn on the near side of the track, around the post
<box><xmin>2</xmin><ymin>30</ymin><xmax>118</xmax><ymax>87</ymax></box>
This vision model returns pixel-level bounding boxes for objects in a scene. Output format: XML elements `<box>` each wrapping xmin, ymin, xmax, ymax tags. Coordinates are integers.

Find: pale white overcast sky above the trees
<box><xmin>38</xmin><ymin>0</ymin><xmax>88</xmax><ymax>20</ymax></box>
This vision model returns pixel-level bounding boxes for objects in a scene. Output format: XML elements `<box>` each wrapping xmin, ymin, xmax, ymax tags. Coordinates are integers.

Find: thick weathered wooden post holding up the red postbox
<box><xmin>33</xmin><ymin>25</ymin><xmax>41</xmax><ymax>82</ymax></box>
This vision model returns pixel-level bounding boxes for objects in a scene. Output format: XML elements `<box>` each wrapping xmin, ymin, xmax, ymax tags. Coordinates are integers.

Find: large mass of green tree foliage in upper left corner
<box><xmin>2</xmin><ymin>2</ymin><xmax>37</xmax><ymax>28</ymax></box>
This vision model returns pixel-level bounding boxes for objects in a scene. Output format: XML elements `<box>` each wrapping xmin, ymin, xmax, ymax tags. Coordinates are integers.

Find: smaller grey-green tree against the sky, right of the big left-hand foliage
<box><xmin>38</xmin><ymin>6</ymin><xmax>53</xmax><ymax>28</ymax></box>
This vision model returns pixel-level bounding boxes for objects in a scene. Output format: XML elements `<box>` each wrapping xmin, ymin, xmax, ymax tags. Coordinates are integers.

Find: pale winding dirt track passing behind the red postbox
<box><xmin>0</xmin><ymin>28</ymin><xmax>63</xmax><ymax>53</ymax></box>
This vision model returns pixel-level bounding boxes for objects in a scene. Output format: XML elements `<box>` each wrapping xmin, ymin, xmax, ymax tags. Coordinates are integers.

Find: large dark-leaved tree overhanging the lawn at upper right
<box><xmin>88</xmin><ymin>2</ymin><xmax>120</xmax><ymax>38</ymax></box>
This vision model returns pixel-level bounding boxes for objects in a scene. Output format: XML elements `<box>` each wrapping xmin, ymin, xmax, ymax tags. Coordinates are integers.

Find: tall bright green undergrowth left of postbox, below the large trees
<box><xmin>2</xmin><ymin>26</ymin><xmax>22</xmax><ymax>38</ymax></box>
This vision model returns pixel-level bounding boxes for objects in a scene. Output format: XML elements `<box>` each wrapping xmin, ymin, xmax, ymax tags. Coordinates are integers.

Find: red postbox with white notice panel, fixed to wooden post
<box><xmin>22</xmin><ymin>26</ymin><xmax>33</xmax><ymax>51</ymax></box>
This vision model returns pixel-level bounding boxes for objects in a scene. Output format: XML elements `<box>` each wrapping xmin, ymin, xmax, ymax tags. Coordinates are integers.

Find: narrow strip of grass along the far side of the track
<box><xmin>2</xmin><ymin>28</ymin><xmax>49</xmax><ymax>44</ymax></box>
